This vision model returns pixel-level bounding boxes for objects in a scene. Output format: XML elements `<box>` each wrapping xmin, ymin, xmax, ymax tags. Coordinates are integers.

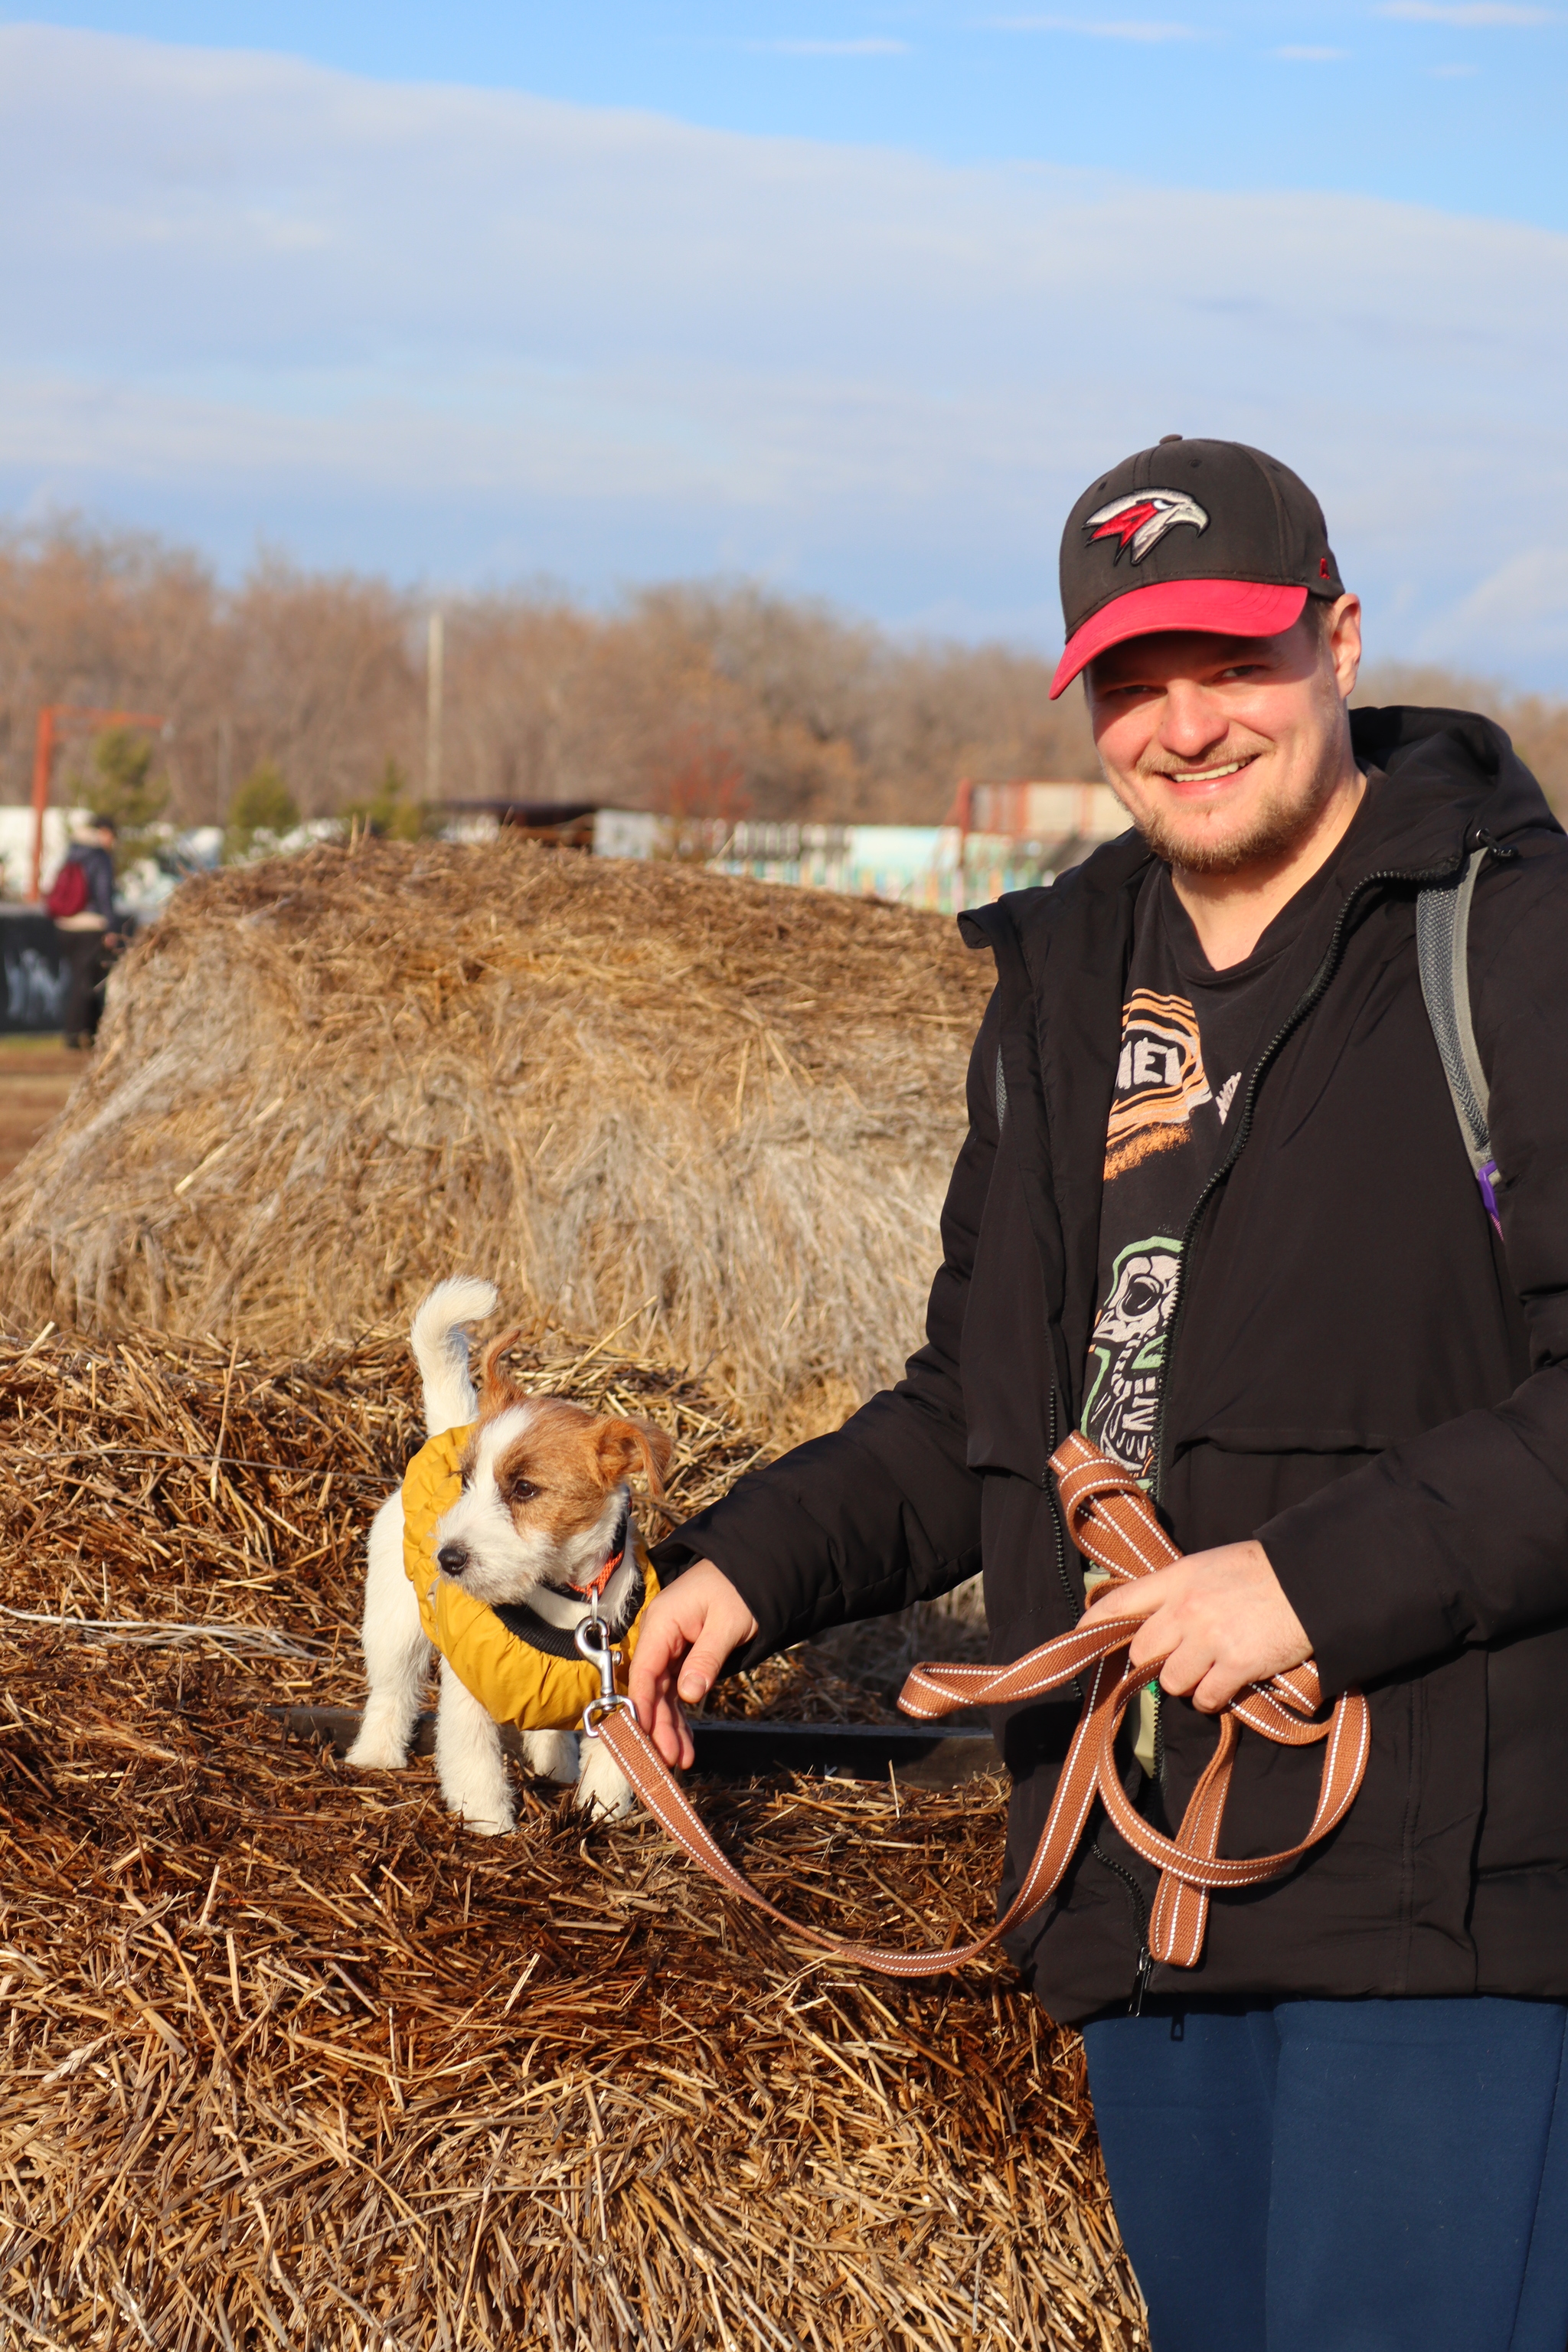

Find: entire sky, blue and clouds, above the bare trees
<box><xmin>0</xmin><ymin>0</ymin><xmax>1568</xmax><ymax>687</ymax></box>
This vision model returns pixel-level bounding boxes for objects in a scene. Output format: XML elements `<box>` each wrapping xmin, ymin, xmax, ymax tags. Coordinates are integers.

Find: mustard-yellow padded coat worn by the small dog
<box><xmin>402</xmin><ymin>1423</ymin><xmax>658</xmax><ymax>1731</ymax></box>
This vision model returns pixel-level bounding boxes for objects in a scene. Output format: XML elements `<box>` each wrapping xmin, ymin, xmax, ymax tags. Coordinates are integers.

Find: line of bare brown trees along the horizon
<box><xmin>0</xmin><ymin>522</ymin><xmax>1568</xmax><ymax>825</ymax></box>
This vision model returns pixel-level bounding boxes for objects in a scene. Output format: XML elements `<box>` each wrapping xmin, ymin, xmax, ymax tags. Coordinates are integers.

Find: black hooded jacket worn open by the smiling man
<box><xmin>661</xmin><ymin>710</ymin><xmax>1568</xmax><ymax>2020</ymax></box>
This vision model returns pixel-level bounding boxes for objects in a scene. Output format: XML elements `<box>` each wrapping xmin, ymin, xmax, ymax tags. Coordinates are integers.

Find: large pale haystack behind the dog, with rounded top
<box><xmin>0</xmin><ymin>840</ymin><xmax>990</xmax><ymax>1428</ymax></box>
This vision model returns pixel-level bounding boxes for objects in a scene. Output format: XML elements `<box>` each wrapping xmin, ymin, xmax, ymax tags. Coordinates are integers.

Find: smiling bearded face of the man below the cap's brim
<box><xmin>1086</xmin><ymin>595</ymin><xmax>1361</xmax><ymax>873</ymax></box>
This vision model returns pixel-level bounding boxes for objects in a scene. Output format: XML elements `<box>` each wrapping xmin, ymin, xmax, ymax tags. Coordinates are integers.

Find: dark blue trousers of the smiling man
<box><xmin>1083</xmin><ymin>1999</ymin><xmax>1568</xmax><ymax>2352</ymax></box>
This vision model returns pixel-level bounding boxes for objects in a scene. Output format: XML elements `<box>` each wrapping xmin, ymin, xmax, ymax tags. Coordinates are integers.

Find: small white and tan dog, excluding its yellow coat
<box><xmin>348</xmin><ymin>1277</ymin><xmax>672</xmax><ymax>1837</ymax></box>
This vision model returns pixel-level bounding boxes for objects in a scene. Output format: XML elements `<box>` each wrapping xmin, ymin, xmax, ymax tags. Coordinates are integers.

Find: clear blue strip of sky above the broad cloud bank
<box><xmin>15</xmin><ymin>0</ymin><xmax>1568</xmax><ymax>228</ymax></box>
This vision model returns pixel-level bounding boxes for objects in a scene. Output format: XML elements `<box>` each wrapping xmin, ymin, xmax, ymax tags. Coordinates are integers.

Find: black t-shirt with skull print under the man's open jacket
<box><xmin>1081</xmin><ymin>865</ymin><xmax>1326</xmax><ymax>1477</ymax></box>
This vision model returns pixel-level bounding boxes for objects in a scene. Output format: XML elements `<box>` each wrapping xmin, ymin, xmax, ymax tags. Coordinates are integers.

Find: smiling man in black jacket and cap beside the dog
<box><xmin>632</xmin><ymin>435</ymin><xmax>1568</xmax><ymax>2352</ymax></box>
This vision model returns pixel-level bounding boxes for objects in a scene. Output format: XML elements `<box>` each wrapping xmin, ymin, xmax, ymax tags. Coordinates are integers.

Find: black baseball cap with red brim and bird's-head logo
<box><xmin>1050</xmin><ymin>433</ymin><xmax>1344</xmax><ymax>701</ymax></box>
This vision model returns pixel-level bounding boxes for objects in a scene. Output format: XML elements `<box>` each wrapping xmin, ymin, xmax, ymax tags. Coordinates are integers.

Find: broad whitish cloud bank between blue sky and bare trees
<box><xmin>0</xmin><ymin>26</ymin><xmax>1568</xmax><ymax>684</ymax></box>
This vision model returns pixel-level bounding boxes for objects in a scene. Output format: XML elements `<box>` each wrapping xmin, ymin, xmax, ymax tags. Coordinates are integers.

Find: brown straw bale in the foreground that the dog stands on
<box><xmin>0</xmin><ymin>1336</ymin><xmax>1145</xmax><ymax>2352</ymax></box>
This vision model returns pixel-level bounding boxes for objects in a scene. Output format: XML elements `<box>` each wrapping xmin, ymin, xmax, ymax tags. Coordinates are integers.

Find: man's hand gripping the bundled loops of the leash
<box><xmin>1086</xmin><ymin>1540</ymin><xmax>1312</xmax><ymax>1714</ymax></box>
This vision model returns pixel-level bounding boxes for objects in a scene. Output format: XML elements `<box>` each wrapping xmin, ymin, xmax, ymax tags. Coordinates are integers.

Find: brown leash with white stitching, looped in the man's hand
<box><xmin>583</xmin><ymin>1435</ymin><xmax>1370</xmax><ymax>1975</ymax></box>
